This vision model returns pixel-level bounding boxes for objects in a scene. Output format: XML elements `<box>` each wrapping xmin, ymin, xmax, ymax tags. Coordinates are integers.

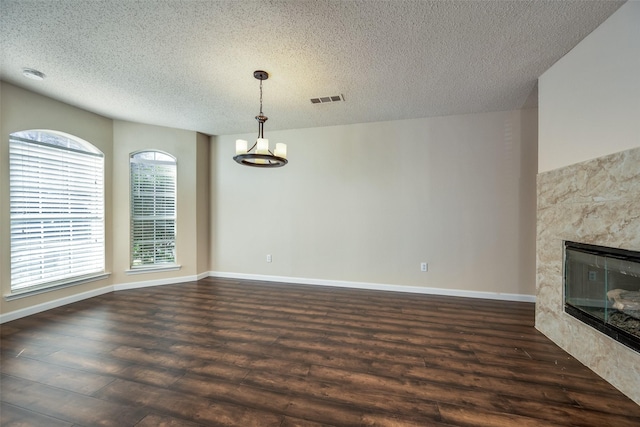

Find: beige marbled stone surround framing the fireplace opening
<box><xmin>536</xmin><ymin>148</ymin><xmax>640</xmax><ymax>404</ymax></box>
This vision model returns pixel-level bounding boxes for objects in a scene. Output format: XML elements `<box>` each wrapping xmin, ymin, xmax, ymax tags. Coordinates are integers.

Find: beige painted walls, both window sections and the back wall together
<box><xmin>0</xmin><ymin>83</ymin><xmax>537</xmax><ymax>314</ymax></box>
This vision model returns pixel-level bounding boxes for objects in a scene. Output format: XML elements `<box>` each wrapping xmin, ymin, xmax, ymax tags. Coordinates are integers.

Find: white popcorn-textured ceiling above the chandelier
<box><xmin>0</xmin><ymin>0</ymin><xmax>623</xmax><ymax>134</ymax></box>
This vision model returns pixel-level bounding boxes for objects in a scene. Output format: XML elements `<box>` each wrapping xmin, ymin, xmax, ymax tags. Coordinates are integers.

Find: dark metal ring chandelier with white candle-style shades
<box><xmin>233</xmin><ymin>70</ymin><xmax>288</xmax><ymax>168</ymax></box>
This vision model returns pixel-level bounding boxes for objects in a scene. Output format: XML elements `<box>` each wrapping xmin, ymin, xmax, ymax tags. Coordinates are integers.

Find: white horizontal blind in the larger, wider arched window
<box><xmin>9</xmin><ymin>131</ymin><xmax>105</xmax><ymax>291</ymax></box>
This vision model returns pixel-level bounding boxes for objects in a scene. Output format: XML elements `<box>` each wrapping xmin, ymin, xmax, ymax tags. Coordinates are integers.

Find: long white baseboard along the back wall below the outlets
<box><xmin>209</xmin><ymin>271</ymin><xmax>536</xmax><ymax>302</ymax></box>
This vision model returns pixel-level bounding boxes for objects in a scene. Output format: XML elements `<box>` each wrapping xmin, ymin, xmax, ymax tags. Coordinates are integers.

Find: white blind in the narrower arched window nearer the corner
<box><xmin>131</xmin><ymin>151</ymin><xmax>176</xmax><ymax>268</ymax></box>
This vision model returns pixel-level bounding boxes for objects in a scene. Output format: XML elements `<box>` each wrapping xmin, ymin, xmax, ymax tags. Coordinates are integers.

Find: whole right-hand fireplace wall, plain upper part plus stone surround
<box><xmin>536</xmin><ymin>2</ymin><xmax>640</xmax><ymax>404</ymax></box>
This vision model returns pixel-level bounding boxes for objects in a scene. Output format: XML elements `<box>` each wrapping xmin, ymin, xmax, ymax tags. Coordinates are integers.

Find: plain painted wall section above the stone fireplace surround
<box><xmin>538</xmin><ymin>1</ymin><xmax>640</xmax><ymax>172</ymax></box>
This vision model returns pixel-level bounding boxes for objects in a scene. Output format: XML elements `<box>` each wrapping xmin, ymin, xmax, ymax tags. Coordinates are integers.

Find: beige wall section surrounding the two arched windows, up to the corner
<box><xmin>0</xmin><ymin>82</ymin><xmax>211</xmax><ymax>320</ymax></box>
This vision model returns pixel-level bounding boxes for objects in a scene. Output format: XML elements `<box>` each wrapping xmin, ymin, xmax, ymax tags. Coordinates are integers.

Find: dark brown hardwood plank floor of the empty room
<box><xmin>0</xmin><ymin>278</ymin><xmax>640</xmax><ymax>427</ymax></box>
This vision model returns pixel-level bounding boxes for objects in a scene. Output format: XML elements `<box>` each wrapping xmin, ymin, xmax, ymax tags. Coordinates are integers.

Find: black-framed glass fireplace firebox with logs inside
<box><xmin>564</xmin><ymin>241</ymin><xmax>640</xmax><ymax>352</ymax></box>
